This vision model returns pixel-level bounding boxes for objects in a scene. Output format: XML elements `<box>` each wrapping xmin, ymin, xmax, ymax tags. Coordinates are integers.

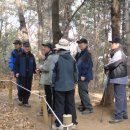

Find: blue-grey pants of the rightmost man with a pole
<box><xmin>114</xmin><ymin>84</ymin><xmax>128</xmax><ymax>119</ymax></box>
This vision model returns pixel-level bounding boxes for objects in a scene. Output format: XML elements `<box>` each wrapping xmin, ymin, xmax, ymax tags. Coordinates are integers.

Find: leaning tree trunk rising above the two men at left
<box><xmin>15</xmin><ymin>0</ymin><xmax>29</xmax><ymax>41</ymax></box>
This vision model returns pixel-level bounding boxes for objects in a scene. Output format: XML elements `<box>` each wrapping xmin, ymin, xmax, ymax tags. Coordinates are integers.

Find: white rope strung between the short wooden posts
<box><xmin>0</xmin><ymin>80</ymin><xmax>73</xmax><ymax>130</ymax></box>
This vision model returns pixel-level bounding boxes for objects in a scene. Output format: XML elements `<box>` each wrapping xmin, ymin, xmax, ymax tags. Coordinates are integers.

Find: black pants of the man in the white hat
<box><xmin>55</xmin><ymin>90</ymin><xmax>76</xmax><ymax>127</ymax></box>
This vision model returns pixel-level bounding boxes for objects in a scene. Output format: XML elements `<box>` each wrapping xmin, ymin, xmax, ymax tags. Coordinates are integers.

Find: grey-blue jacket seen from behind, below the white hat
<box><xmin>50</xmin><ymin>50</ymin><xmax>77</xmax><ymax>92</ymax></box>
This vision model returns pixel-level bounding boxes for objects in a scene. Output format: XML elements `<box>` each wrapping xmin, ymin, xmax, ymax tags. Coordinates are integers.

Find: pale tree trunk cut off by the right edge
<box><xmin>125</xmin><ymin>0</ymin><xmax>130</xmax><ymax>77</ymax></box>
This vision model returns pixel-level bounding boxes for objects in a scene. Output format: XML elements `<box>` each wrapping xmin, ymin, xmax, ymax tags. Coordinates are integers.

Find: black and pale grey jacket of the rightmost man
<box><xmin>105</xmin><ymin>48</ymin><xmax>128</xmax><ymax>84</ymax></box>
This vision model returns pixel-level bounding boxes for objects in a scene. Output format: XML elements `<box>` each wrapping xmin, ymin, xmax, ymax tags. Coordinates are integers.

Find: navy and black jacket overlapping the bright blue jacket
<box><xmin>15</xmin><ymin>52</ymin><xmax>36</xmax><ymax>77</ymax></box>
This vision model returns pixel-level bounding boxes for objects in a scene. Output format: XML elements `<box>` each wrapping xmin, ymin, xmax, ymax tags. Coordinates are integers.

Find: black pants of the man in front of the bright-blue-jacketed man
<box><xmin>18</xmin><ymin>77</ymin><xmax>32</xmax><ymax>104</ymax></box>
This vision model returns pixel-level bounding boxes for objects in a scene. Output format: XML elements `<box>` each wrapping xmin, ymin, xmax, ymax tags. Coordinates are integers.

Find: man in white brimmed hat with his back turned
<box><xmin>50</xmin><ymin>39</ymin><xmax>77</xmax><ymax>130</ymax></box>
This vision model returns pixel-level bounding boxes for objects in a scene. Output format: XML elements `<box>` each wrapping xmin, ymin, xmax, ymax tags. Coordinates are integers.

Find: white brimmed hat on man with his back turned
<box><xmin>56</xmin><ymin>39</ymin><xmax>70</xmax><ymax>50</ymax></box>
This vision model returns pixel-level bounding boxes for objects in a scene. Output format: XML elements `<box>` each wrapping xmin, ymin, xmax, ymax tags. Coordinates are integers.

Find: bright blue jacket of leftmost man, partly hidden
<box><xmin>9</xmin><ymin>48</ymin><xmax>23</xmax><ymax>72</ymax></box>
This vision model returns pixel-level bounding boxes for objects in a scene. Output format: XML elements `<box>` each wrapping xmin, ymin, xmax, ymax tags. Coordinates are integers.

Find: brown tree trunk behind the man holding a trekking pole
<box><xmin>101</xmin><ymin>0</ymin><xmax>120</xmax><ymax>106</ymax></box>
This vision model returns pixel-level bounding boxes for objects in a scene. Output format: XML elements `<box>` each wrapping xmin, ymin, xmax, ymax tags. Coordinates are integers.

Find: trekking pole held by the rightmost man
<box><xmin>100</xmin><ymin>73</ymin><xmax>109</xmax><ymax>122</ymax></box>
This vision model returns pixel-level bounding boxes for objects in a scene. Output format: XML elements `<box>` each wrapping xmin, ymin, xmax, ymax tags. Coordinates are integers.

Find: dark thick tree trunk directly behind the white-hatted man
<box><xmin>52</xmin><ymin>0</ymin><xmax>62</xmax><ymax>44</ymax></box>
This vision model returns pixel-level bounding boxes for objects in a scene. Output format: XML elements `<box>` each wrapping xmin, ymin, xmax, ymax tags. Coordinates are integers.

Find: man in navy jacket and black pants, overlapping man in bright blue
<box><xmin>15</xmin><ymin>42</ymin><xmax>36</xmax><ymax>107</ymax></box>
